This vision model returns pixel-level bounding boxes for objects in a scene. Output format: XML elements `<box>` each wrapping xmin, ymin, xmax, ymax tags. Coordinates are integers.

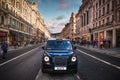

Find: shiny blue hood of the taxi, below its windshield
<box><xmin>47</xmin><ymin>50</ymin><xmax>73</xmax><ymax>57</ymax></box>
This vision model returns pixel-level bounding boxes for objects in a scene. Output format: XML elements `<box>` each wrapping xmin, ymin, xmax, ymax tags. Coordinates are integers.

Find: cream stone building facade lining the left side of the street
<box><xmin>0</xmin><ymin>0</ymin><xmax>50</xmax><ymax>44</ymax></box>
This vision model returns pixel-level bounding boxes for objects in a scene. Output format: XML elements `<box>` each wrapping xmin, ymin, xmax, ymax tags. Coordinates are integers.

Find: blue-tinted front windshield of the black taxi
<box><xmin>46</xmin><ymin>40</ymin><xmax>72</xmax><ymax>50</ymax></box>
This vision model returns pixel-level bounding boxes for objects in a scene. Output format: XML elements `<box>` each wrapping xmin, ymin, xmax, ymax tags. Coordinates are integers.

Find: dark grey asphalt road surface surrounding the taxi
<box><xmin>0</xmin><ymin>45</ymin><xmax>120</xmax><ymax>80</ymax></box>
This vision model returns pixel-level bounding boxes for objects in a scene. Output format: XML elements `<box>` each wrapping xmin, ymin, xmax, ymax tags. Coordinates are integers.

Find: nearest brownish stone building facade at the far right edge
<box><xmin>92</xmin><ymin>0</ymin><xmax>120</xmax><ymax>47</ymax></box>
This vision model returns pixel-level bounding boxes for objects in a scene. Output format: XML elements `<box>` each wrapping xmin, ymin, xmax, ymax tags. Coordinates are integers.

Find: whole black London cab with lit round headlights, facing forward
<box><xmin>42</xmin><ymin>39</ymin><xmax>78</xmax><ymax>73</ymax></box>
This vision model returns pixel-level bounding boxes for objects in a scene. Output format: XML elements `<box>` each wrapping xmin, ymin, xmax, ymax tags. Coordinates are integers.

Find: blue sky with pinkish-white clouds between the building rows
<box><xmin>29</xmin><ymin>0</ymin><xmax>82</xmax><ymax>33</ymax></box>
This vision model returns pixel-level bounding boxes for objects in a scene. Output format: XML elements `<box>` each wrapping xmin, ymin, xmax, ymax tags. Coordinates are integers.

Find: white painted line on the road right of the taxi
<box><xmin>77</xmin><ymin>49</ymin><xmax>120</xmax><ymax>69</ymax></box>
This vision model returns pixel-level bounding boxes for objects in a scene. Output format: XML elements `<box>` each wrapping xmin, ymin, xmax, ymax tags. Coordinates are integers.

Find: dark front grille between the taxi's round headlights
<box><xmin>54</xmin><ymin>57</ymin><xmax>67</xmax><ymax>66</ymax></box>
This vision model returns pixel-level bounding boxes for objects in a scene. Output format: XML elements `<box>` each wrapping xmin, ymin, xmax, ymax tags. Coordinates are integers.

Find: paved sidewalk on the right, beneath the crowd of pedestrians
<box><xmin>78</xmin><ymin>45</ymin><xmax>120</xmax><ymax>58</ymax></box>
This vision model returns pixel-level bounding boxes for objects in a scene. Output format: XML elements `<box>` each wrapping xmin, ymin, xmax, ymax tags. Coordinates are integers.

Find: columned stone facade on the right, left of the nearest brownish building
<box><xmin>76</xmin><ymin>0</ymin><xmax>93</xmax><ymax>41</ymax></box>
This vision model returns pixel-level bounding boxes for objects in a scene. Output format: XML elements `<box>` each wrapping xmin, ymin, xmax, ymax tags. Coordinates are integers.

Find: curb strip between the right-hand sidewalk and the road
<box><xmin>77</xmin><ymin>45</ymin><xmax>120</xmax><ymax>58</ymax></box>
